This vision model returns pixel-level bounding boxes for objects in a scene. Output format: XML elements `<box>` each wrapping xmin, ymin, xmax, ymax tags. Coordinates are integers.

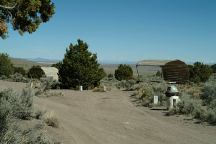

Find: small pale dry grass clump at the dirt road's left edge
<box><xmin>43</xmin><ymin>112</ymin><xmax>59</xmax><ymax>128</ymax></box>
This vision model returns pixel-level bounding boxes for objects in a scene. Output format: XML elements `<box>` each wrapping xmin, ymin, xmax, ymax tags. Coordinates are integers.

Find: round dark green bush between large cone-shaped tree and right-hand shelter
<box><xmin>115</xmin><ymin>64</ymin><xmax>133</xmax><ymax>81</ymax></box>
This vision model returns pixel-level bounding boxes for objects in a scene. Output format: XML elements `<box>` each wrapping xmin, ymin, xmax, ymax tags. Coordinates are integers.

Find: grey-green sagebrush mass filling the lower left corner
<box><xmin>0</xmin><ymin>88</ymin><xmax>58</xmax><ymax>144</ymax></box>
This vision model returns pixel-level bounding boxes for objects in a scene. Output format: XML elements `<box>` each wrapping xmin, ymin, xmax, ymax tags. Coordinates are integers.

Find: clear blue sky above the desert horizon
<box><xmin>0</xmin><ymin>0</ymin><xmax>216</xmax><ymax>62</ymax></box>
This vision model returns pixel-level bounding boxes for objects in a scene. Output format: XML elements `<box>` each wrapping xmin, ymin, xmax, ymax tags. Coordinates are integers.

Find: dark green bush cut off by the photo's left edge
<box><xmin>0</xmin><ymin>53</ymin><xmax>13</xmax><ymax>77</ymax></box>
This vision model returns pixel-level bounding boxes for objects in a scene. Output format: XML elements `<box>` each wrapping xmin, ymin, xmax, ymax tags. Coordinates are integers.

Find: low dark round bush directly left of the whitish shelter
<box><xmin>28</xmin><ymin>66</ymin><xmax>45</xmax><ymax>79</ymax></box>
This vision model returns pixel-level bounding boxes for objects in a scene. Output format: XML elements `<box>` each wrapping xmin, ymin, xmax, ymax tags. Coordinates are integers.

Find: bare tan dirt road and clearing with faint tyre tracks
<box><xmin>0</xmin><ymin>81</ymin><xmax>216</xmax><ymax>144</ymax></box>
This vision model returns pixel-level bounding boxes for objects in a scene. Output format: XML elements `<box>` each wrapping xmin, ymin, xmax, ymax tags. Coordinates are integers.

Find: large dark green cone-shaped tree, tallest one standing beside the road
<box><xmin>59</xmin><ymin>40</ymin><xmax>105</xmax><ymax>89</ymax></box>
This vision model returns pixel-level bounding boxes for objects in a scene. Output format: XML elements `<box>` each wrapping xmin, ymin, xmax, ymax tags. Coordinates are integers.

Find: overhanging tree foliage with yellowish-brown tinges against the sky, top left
<box><xmin>0</xmin><ymin>0</ymin><xmax>55</xmax><ymax>38</ymax></box>
